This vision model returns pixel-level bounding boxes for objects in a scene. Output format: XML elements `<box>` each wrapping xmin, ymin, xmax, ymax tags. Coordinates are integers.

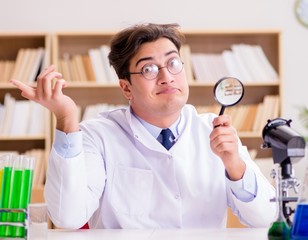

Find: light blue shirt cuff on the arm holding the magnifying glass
<box><xmin>227</xmin><ymin>166</ymin><xmax>257</xmax><ymax>202</ymax></box>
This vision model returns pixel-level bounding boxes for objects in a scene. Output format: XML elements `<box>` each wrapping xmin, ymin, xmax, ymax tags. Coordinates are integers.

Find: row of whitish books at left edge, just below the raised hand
<box><xmin>0</xmin><ymin>93</ymin><xmax>46</xmax><ymax>136</ymax></box>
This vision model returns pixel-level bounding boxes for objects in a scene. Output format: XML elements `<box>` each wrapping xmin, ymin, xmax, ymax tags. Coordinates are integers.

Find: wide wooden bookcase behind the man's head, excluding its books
<box><xmin>52</xmin><ymin>30</ymin><xmax>282</xmax><ymax>158</ymax></box>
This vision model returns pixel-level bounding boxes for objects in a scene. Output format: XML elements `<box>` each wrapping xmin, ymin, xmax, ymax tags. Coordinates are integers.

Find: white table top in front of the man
<box><xmin>48</xmin><ymin>228</ymin><xmax>268</xmax><ymax>240</ymax></box>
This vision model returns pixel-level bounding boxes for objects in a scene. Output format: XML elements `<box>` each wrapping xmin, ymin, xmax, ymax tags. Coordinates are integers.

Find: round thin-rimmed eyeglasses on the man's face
<box><xmin>126</xmin><ymin>57</ymin><xmax>184</xmax><ymax>80</ymax></box>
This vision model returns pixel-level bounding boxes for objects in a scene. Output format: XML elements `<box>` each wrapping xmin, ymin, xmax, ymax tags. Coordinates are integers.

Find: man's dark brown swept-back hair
<box><xmin>108</xmin><ymin>23</ymin><xmax>185</xmax><ymax>81</ymax></box>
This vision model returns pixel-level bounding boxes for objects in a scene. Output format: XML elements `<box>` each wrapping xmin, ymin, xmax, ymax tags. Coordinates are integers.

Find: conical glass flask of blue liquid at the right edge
<box><xmin>291</xmin><ymin>165</ymin><xmax>308</xmax><ymax>240</ymax></box>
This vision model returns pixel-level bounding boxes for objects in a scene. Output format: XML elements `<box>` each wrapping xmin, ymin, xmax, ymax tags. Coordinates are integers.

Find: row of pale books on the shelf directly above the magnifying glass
<box><xmin>182</xmin><ymin>44</ymin><xmax>279</xmax><ymax>83</ymax></box>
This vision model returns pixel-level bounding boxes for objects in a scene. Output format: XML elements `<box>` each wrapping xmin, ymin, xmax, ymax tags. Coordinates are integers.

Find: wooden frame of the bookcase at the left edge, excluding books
<box><xmin>0</xmin><ymin>32</ymin><xmax>51</xmax><ymax>202</ymax></box>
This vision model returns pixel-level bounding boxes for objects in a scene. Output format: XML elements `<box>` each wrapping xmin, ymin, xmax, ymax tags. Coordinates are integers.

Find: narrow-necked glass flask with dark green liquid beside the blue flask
<box><xmin>267</xmin><ymin>166</ymin><xmax>290</xmax><ymax>240</ymax></box>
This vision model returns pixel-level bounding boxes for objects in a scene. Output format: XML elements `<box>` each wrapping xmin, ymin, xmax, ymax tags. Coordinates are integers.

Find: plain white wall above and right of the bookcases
<box><xmin>0</xmin><ymin>0</ymin><xmax>308</xmax><ymax>134</ymax></box>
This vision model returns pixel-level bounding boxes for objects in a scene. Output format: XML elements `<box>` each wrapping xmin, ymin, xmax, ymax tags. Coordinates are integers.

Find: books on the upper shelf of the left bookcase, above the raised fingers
<box><xmin>0</xmin><ymin>47</ymin><xmax>46</xmax><ymax>84</ymax></box>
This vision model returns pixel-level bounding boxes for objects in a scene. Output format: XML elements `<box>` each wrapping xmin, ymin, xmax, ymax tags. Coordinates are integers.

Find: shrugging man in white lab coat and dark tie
<box><xmin>12</xmin><ymin>24</ymin><xmax>276</xmax><ymax>228</ymax></box>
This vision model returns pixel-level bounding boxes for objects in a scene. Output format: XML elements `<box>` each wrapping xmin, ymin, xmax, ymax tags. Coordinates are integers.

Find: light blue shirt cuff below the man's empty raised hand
<box><xmin>53</xmin><ymin>129</ymin><xmax>82</xmax><ymax>158</ymax></box>
